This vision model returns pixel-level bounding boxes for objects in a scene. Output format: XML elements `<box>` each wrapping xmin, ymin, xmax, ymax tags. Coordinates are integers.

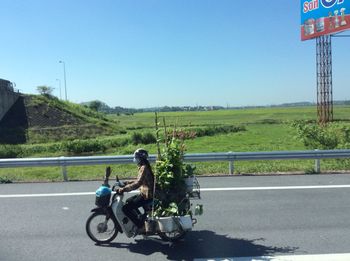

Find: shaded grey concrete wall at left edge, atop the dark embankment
<box><xmin>0</xmin><ymin>79</ymin><xmax>20</xmax><ymax>121</ymax></box>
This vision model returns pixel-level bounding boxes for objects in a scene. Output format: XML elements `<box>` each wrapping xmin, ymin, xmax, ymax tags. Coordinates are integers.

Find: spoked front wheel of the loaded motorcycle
<box><xmin>85</xmin><ymin>212</ymin><xmax>118</xmax><ymax>244</ymax></box>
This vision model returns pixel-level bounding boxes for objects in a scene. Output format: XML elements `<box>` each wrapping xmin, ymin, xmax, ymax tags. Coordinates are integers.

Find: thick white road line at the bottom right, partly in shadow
<box><xmin>194</xmin><ymin>253</ymin><xmax>350</xmax><ymax>261</ymax></box>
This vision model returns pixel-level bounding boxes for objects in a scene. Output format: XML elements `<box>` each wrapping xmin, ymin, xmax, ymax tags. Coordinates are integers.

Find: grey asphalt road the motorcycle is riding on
<box><xmin>0</xmin><ymin>174</ymin><xmax>350</xmax><ymax>261</ymax></box>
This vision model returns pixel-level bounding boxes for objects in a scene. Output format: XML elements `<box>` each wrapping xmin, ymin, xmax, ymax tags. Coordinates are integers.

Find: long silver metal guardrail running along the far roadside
<box><xmin>0</xmin><ymin>150</ymin><xmax>350</xmax><ymax>181</ymax></box>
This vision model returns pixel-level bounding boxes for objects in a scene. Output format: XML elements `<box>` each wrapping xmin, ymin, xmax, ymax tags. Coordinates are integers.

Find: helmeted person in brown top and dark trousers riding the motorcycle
<box><xmin>118</xmin><ymin>149</ymin><xmax>154</xmax><ymax>228</ymax></box>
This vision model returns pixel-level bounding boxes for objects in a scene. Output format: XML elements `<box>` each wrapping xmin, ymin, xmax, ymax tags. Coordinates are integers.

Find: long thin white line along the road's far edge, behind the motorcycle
<box><xmin>0</xmin><ymin>185</ymin><xmax>350</xmax><ymax>198</ymax></box>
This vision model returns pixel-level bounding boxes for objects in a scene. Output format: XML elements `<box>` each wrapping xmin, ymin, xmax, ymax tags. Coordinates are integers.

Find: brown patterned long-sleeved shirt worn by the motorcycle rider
<box><xmin>123</xmin><ymin>165</ymin><xmax>154</xmax><ymax>199</ymax></box>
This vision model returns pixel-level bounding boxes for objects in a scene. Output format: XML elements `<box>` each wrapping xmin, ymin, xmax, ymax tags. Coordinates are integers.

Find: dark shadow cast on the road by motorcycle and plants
<box><xmin>101</xmin><ymin>231</ymin><xmax>298</xmax><ymax>260</ymax></box>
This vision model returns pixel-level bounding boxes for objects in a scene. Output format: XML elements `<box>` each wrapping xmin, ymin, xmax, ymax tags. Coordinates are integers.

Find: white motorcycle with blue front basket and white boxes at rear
<box><xmin>86</xmin><ymin>167</ymin><xmax>203</xmax><ymax>244</ymax></box>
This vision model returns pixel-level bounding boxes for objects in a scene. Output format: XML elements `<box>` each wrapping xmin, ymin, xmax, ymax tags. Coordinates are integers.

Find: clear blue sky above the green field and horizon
<box><xmin>0</xmin><ymin>0</ymin><xmax>350</xmax><ymax>108</ymax></box>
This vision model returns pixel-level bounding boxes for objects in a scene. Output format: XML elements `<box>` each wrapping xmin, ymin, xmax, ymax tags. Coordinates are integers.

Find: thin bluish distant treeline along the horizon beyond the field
<box><xmin>83</xmin><ymin>100</ymin><xmax>350</xmax><ymax>115</ymax></box>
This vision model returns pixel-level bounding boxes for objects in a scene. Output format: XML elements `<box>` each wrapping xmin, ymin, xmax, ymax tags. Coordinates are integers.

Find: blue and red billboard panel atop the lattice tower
<box><xmin>301</xmin><ymin>0</ymin><xmax>350</xmax><ymax>41</ymax></box>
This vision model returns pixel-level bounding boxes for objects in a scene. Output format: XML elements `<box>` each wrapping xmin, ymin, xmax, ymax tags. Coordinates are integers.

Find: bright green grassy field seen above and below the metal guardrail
<box><xmin>0</xmin><ymin>106</ymin><xmax>350</xmax><ymax>182</ymax></box>
